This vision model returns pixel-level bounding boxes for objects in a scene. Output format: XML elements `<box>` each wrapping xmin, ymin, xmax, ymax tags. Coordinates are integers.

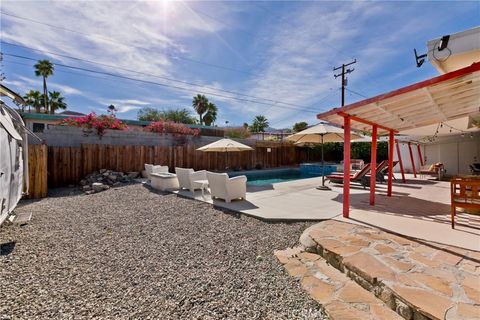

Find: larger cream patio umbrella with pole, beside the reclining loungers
<box><xmin>286</xmin><ymin>123</ymin><xmax>362</xmax><ymax>190</ymax></box>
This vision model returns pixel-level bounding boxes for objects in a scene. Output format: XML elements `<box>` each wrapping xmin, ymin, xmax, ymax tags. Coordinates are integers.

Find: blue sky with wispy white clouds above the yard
<box><xmin>0</xmin><ymin>0</ymin><xmax>480</xmax><ymax>128</ymax></box>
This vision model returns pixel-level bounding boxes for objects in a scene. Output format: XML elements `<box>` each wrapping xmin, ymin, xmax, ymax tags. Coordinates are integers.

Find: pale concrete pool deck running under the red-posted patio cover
<box><xmin>175</xmin><ymin>175</ymin><xmax>480</xmax><ymax>251</ymax></box>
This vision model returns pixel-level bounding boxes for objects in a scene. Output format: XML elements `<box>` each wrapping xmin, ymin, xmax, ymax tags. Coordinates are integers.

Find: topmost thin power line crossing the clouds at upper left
<box><xmin>0</xmin><ymin>10</ymin><xmax>252</xmax><ymax>75</ymax></box>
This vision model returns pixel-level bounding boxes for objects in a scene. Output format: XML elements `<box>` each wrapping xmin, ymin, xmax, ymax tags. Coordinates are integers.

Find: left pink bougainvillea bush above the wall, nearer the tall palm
<box><xmin>60</xmin><ymin>112</ymin><xmax>128</xmax><ymax>136</ymax></box>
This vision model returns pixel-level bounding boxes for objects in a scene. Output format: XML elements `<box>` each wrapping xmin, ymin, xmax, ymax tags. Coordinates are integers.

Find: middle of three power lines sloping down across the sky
<box><xmin>0</xmin><ymin>40</ymin><xmax>316</xmax><ymax>108</ymax></box>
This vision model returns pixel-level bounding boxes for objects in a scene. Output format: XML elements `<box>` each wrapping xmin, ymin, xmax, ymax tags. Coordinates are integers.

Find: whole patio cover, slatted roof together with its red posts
<box><xmin>317</xmin><ymin>62</ymin><xmax>480</xmax><ymax>218</ymax></box>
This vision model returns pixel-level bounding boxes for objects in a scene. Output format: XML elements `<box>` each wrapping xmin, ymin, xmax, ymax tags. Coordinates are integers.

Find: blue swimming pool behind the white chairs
<box><xmin>230</xmin><ymin>168</ymin><xmax>321</xmax><ymax>186</ymax></box>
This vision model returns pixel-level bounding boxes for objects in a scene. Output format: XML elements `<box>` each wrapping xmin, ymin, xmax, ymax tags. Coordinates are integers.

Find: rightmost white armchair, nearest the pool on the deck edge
<box><xmin>207</xmin><ymin>172</ymin><xmax>247</xmax><ymax>202</ymax></box>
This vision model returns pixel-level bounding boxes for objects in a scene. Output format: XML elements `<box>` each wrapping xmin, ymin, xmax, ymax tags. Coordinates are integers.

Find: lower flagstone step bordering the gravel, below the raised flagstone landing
<box><xmin>275</xmin><ymin>247</ymin><xmax>402</xmax><ymax>320</ymax></box>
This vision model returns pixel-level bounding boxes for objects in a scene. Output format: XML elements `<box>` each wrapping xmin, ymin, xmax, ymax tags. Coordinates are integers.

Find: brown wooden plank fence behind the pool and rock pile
<box><xmin>28</xmin><ymin>142</ymin><xmax>318</xmax><ymax>192</ymax></box>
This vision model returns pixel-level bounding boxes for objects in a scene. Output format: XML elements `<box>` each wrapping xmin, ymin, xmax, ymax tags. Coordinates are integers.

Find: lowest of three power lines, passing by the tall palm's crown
<box><xmin>3</xmin><ymin>53</ymin><xmax>316</xmax><ymax>113</ymax></box>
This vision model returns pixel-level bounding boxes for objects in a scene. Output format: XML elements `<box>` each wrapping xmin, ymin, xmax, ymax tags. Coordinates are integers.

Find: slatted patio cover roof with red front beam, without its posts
<box><xmin>317</xmin><ymin>62</ymin><xmax>480</xmax><ymax>134</ymax></box>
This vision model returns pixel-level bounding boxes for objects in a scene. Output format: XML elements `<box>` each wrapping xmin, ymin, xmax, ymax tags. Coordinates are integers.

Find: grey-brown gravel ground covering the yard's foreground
<box><xmin>0</xmin><ymin>184</ymin><xmax>322</xmax><ymax>319</ymax></box>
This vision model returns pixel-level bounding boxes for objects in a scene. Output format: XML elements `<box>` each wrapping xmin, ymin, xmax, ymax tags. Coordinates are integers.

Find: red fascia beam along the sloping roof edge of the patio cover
<box><xmin>317</xmin><ymin>62</ymin><xmax>480</xmax><ymax>119</ymax></box>
